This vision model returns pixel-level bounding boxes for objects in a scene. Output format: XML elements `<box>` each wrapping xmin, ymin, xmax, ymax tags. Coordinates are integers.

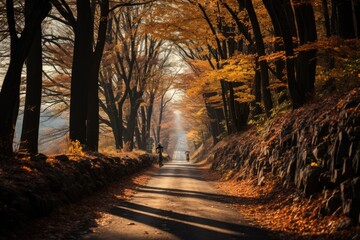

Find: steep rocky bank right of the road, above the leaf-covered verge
<box><xmin>211</xmin><ymin>89</ymin><xmax>360</xmax><ymax>225</ymax></box>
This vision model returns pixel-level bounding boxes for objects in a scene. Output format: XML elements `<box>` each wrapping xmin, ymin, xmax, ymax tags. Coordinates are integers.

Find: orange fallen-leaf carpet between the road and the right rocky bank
<box><xmin>206</xmin><ymin>168</ymin><xmax>360</xmax><ymax>240</ymax></box>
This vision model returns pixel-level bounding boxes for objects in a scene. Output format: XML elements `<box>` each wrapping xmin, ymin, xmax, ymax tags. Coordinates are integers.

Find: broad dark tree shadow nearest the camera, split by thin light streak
<box><xmin>110</xmin><ymin>201</ymin><xmax>269</xmax><ymax>240</ymax></box>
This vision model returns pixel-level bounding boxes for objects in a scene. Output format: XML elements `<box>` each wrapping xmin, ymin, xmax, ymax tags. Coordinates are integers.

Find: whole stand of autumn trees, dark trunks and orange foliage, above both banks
<box><xmin>0</xmin><ymin>0</ymin><xmax>360</xmax><ymax>154</ymax></box>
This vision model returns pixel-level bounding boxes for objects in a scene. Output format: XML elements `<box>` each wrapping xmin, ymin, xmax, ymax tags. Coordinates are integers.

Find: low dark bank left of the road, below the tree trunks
<box><xmin>0</xmin><ymin>154</ymin><xmax>161</xmax><ymax>232</ymax></box>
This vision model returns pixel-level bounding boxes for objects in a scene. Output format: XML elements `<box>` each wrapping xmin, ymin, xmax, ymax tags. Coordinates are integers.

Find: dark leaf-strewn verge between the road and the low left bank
<box><xmin>0</xmin><ymin>167</ymin><xmax>156</xmax><ymax>240</ymax></box>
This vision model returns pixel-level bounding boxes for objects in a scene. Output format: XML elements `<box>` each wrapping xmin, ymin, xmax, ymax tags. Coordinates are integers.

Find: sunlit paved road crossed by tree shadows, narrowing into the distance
<box><xmin>84</xmin><ymin>160</ymin><xmax>269</xmax><ymax>240</ymax></box>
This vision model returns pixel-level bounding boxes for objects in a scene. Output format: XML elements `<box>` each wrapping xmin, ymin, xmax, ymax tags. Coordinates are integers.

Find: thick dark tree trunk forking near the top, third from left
<box><xmin>52</xmin><ymin>0</ymin><xmax>110</xmax><ymax>151</ymax></box>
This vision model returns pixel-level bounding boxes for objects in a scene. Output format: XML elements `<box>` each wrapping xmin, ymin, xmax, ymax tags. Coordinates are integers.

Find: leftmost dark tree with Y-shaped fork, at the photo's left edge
<box><xmin>0</xmin><ymin>0</ymin><xmax>51</xmax><ymax>154</ymax></box>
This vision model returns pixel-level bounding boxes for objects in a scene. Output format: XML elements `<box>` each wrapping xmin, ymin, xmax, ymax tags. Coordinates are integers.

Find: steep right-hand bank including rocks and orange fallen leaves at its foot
<box><xmin>202</xmin><ymin>88</ymin><xmax>360</xmax><ymax>239</ymax></box>
